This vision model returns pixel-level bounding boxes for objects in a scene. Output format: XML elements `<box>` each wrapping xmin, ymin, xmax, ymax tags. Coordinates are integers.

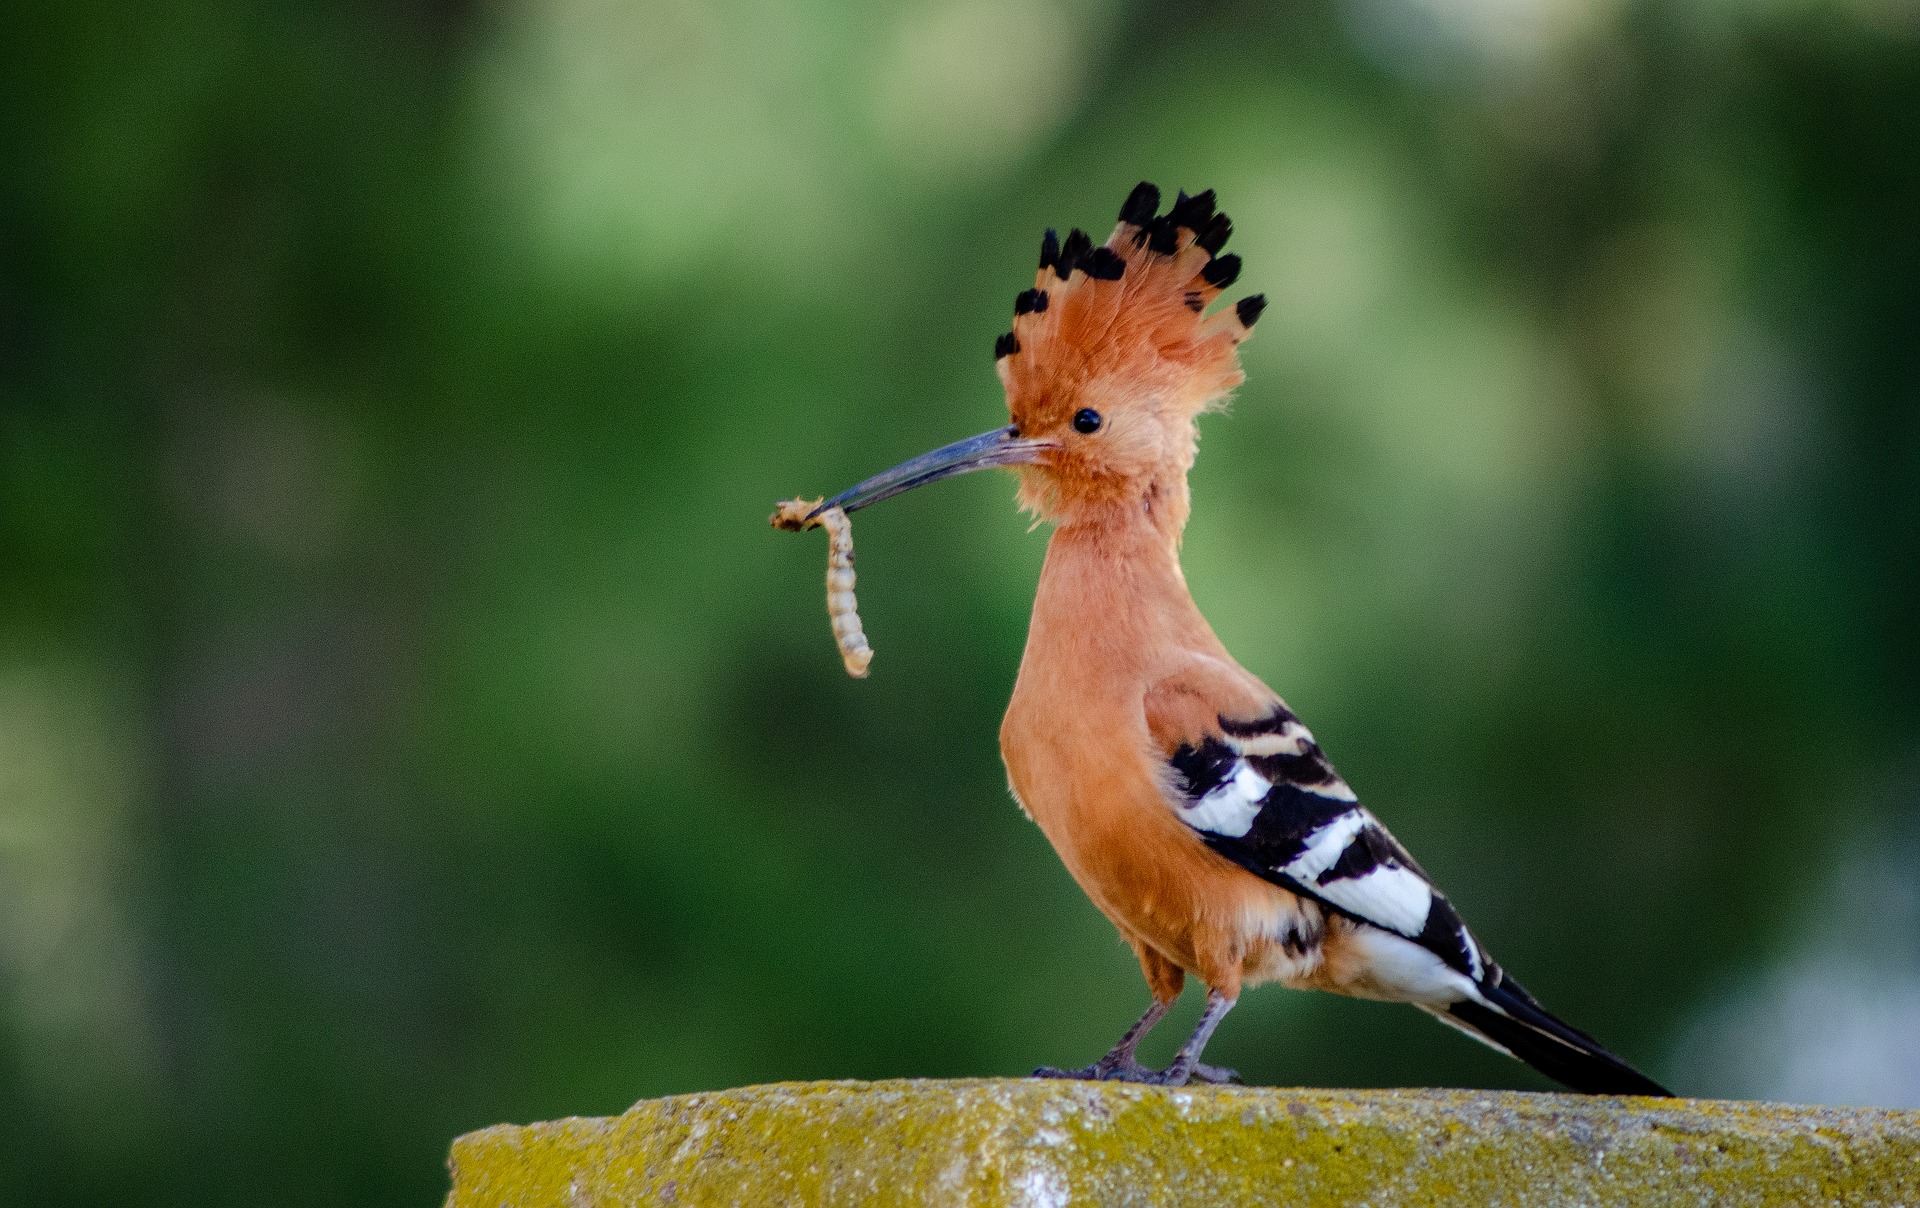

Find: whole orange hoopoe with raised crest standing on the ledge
<box><xmin>816</xmin><ymin>182</ymin><xmax>1667</xmax><ymax>1095</ymax></box>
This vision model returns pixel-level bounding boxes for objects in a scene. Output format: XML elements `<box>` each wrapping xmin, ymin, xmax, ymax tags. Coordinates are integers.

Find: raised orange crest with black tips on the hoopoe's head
<box><xmin>995</xmin><ymin>181</ymin><xmax>1265</xmax><ymax>430</ymax></box>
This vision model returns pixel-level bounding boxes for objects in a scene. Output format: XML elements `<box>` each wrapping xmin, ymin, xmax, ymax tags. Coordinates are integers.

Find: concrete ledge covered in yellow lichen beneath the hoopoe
<box><xmin>447</xmin><ymin>1079</ymin><xmax>1920</xmax><ymax>1208</ymax></box>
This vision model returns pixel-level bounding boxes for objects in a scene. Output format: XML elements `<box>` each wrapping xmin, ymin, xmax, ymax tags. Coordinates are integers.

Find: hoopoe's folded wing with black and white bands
<box><xmin>1167</xmin><ymin>705</ymin><xmax>1498</xmax><ymax>983</ymax></box>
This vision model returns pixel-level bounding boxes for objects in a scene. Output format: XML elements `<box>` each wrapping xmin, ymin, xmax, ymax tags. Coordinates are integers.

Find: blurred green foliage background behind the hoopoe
<box><xmin>0</xmin><ymin>0</ymin><xmax>1920</xmax><ymax>1204</ymax></box>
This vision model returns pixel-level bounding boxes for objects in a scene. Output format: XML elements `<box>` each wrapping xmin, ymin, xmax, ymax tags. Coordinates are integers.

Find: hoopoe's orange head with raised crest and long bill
<box><xmin>806</xmin><ymin>182</ymin><xmax>1265</xmax><ymax>536</ymax></box>
